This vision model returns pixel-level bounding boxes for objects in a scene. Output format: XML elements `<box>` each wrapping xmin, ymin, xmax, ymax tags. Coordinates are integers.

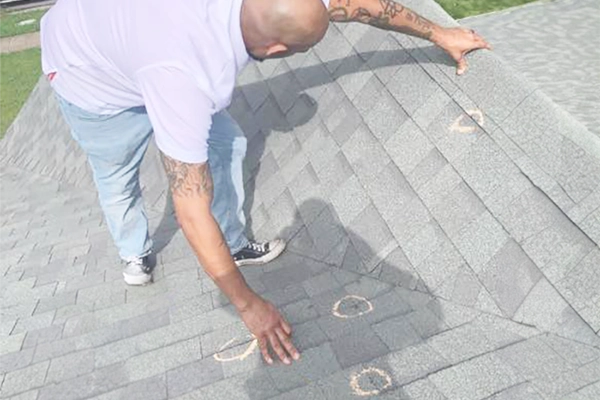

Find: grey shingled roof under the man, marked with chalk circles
<box><xmin>0</xmin><ymin>1</ymin><xmax>600</xmax><ymax>399</ymax></box>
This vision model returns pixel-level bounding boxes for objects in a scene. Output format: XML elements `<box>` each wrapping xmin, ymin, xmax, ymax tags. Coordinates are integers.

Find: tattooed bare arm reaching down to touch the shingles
<box><xmin>161</xmin><ymin>153</ymin><xmax>299</xmax><ymax>364</ymax></box>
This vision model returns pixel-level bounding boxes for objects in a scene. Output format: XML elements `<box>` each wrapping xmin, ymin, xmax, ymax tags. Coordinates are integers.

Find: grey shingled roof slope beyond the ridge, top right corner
<box><xmin>462</xmin><ymin>0</ymin><xmax>600</xmax><ymax>135</ymax></box>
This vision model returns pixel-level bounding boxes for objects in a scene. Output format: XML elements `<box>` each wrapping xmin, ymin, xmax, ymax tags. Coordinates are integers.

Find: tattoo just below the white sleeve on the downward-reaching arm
<box><xmin>161</xmin><ymin>153</ymin><xmax>213</xmax><ymax>197</ymax></box>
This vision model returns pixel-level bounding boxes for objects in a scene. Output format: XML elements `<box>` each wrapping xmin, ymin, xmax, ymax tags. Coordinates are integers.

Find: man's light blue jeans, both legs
<box><xmin>57</xmin><ymin>96</ymin><xmax>248</xmax><ymax>260</ymax></box>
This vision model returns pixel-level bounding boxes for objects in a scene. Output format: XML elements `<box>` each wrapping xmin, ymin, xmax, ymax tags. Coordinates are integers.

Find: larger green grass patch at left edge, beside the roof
<box><xmin>0</xmin><ymin>49</ymin><xmax>42</xmax><ymax>139</ymax></box>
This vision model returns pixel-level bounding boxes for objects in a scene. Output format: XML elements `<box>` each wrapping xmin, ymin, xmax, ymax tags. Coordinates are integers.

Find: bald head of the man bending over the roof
<box><xmin>241</xmin><ymin>0</ymin><xmax>329</xmax><ymax>59</ymax></box>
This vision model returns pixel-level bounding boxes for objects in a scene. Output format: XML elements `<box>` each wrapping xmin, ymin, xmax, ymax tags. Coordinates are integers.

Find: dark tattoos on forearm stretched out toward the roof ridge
<box><xmin>329</xmin><ymin>0</ymin><xmax>433</xmax><ymax>39</ymax></box>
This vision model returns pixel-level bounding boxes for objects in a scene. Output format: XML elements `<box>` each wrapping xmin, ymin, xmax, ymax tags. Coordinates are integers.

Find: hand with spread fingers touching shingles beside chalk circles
<box><xmin>239</xmin><ymin>296</ymin><xmax>300</xmax><ymax>364</ymax></box>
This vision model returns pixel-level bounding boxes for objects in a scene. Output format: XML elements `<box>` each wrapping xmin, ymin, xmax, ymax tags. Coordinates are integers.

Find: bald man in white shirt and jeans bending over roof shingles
<box><xmin>41</xmin><ymin>0</ymin><xmax>488</xmax><ymax>364</ymax></box>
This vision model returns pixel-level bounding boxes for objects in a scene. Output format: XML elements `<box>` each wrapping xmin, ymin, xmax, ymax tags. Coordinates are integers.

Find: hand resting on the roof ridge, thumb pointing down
<box><xmin>435</xmin><ymin>28</ymin><xmax>492</xmax><ymax>75</ymax></box>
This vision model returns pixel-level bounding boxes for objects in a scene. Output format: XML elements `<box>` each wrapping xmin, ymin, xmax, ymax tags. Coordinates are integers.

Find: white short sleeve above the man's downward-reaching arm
<box><xmin>136</xmin><ymin>66</ymin><xmax>214</xmax><ymax>163</ymax></box>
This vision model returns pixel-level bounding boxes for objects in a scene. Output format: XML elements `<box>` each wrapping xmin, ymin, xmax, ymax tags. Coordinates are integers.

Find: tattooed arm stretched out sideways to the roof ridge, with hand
<box><xmin>329</xmin><ymin>0</ymin><xmax>491</xmax><ymax>75</ymax></box>
